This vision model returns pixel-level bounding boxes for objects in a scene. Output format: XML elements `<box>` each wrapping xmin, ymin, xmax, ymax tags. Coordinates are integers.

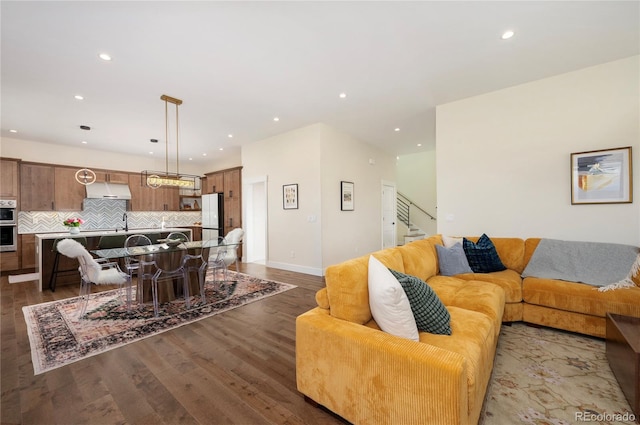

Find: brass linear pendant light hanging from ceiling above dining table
<box><xmin>140</xmin><ymin>94</ymin><xmax>200</xmax><ymax>190</ymax></box>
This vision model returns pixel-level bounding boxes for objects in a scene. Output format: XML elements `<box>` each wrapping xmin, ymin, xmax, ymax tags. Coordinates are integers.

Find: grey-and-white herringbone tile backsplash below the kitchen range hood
<box><xmin>18</xmin><ymin>199</ymin><xmax>202</xmax><ymax>234</ymax></box>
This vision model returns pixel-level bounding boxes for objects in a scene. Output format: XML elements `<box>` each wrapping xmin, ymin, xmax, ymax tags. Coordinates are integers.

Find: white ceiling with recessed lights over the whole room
<box><xmin>0</xmin><ymin>1</ymin><xmax>640</xmax><ymax>161</ymax></box>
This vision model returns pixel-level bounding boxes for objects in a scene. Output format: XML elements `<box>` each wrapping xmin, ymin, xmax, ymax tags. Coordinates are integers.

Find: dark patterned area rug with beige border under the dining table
<box><xmin>22</xmin><ymin>271</ymin><xmax>296</xmax><ymax>375</ymax></box>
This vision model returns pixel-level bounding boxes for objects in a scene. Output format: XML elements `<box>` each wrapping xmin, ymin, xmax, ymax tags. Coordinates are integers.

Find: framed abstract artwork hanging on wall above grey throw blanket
<box><xmin>571</xmin><ymin>146</ymin><xmax>633</xmax><ymax>205</ymax></box>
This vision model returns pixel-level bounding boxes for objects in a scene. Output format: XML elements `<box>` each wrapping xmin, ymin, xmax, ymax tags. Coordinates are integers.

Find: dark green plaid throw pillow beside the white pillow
<box><xmin>389</xmin><ymin>269</ymin><xmax>451</xmax><ymax>335</ymax></box>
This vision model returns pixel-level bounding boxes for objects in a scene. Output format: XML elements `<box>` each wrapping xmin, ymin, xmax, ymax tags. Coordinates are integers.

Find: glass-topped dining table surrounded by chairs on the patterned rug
<box><xmin>91</xmin><ymin>239</ymin><xmax>239</xmax><ymax>303</ymax></box>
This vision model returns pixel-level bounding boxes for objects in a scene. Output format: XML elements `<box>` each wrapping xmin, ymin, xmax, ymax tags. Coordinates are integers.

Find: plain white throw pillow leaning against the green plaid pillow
<box><xmin>368</xmin><ymin>255</ymin><xmax>419</xmax><ymax>341</ymax></box>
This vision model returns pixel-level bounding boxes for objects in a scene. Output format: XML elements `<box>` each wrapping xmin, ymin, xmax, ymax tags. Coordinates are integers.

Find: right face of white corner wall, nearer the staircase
<box><xmin>321</xmin><ymin>124</ymin><xmax>395</xmax><ymax>268</ymax></box>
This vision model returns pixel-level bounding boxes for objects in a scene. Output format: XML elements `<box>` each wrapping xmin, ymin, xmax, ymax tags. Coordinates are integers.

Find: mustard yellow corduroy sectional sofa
<box><xmin>296</xmin><ymin>235</ymin><xmax>640</xmax><ymax>425</ymax></box>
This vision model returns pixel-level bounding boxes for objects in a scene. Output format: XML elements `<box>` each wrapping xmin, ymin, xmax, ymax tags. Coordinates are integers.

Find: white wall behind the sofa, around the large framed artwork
<box><xmin>436</xmin><ymin>56</ymin><xmax>640</xmax><ymax>245</ymax></box>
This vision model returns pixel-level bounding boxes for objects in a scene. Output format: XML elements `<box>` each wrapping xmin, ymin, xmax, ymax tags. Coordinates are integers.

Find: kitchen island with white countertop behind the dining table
<box><xmin>35</xmin><ymin>227</ymin><xmax>192</xmax><ymax>292</ymax></box>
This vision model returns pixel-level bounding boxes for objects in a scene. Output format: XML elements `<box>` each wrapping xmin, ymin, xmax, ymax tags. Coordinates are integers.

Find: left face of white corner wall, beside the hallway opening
<box><xmin>242</xmin><ymin>124</ymin><xmax>322</xmax><ymax>275</ymax></box>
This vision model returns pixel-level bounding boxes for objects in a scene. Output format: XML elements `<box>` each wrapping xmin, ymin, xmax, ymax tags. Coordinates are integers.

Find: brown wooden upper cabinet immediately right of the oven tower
<box><xmin>20</xmin><ymin>162</ymin><xmax>55</xmax><ymax>211</ymax></box>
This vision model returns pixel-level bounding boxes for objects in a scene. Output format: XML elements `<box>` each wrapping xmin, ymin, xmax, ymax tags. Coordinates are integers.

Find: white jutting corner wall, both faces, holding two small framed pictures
<box><xmin>242</xmin><ymin>123</ymin><xmax>395</xmax><ymax>275</ymax></box>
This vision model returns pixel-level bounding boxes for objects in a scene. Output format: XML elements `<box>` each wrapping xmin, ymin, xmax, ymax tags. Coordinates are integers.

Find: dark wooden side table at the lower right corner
<box><xmin>606</xmin><ymin>313</ymin><xmax>640</xmax><ymax>423</ymax></box>
